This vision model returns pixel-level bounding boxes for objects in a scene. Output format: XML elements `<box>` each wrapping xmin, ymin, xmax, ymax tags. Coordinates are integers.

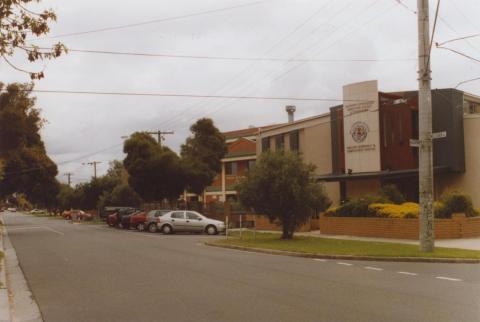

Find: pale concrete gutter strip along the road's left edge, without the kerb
<box><xmin>1</xmin><ymin>215</ymin><xmax>44</xmax><ymax>322</ymax></box>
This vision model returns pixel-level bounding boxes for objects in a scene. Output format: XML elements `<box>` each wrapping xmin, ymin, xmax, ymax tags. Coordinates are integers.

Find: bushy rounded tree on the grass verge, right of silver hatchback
<box><xmin>237</xmin><ymin>151</ymin><xmax>331</xmax><ymax>239</ymax></box>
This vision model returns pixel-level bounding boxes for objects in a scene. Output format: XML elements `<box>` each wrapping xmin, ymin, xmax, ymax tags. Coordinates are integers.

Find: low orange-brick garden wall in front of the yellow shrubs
<box><xmin>320</xmin><ymin>214</ymin><xmax>480</xmax><ymax>239</ymax></box>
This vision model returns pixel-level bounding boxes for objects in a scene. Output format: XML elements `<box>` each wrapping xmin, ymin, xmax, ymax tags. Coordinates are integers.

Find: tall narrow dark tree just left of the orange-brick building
<box><xmin>180</xmin><ymin>118</ymin><xmax>227</xmax><ymax>194</ymax></box>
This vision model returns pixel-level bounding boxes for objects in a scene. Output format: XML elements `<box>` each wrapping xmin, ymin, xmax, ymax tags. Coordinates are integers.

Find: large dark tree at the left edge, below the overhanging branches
<box><xmin>0</xmin><ymin>83</ymin><xmax>59</xmax><ymax>207</ymax></box>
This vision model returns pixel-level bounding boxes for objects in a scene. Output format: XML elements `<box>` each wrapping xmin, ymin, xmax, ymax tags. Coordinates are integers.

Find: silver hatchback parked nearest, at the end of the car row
<box><xmin>157</xmin><ymin>210</ymin><xmax>225</xmax><ymax>235</ymax></box>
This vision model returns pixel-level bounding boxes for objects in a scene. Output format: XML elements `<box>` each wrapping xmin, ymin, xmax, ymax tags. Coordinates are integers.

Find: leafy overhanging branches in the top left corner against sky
<box><xmin>0</xmin><ymin>0</ymin><xmax>67</xmax><ymax>79</ymax></box>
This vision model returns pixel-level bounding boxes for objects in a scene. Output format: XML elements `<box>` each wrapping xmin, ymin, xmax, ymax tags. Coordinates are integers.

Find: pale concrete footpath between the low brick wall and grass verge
<box><xmin>248</xmin><ymin>229</ymin><xmax>480</xmax><ymax>250</ymax></box>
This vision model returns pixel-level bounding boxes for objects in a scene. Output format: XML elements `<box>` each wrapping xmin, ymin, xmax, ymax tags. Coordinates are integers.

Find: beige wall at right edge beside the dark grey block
<box><xmin>435</xmin><ymin>114</ymin><xmax>480</xmax><ymax>207</ymax></box>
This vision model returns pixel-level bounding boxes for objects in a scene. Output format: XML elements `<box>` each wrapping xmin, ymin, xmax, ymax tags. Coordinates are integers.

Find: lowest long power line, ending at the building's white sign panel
<box><xmin>0</xmin><ymin>89</ymin><xmax>368</xmax><ymax>102</ymax></box>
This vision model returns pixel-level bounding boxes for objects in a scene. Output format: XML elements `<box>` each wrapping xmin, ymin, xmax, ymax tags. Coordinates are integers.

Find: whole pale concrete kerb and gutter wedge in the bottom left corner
<box><xmin>0</xmin><ymin>216</ymin><xmax>43</xmax><ymax>322</ymax></box>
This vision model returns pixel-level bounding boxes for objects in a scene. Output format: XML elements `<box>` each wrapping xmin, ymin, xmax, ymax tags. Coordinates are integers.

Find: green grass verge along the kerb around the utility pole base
<box><xmin>215</xmin><ymin>232</ymin><xmax>480</xmax><ymax>259</ymax></box>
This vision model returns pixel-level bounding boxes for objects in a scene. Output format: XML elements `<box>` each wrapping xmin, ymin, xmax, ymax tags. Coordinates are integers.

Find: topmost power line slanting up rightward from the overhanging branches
<box><xmin>39</xmin><ymin>0</ymin><xmax>271</xmax><ymax>39</ymax></box>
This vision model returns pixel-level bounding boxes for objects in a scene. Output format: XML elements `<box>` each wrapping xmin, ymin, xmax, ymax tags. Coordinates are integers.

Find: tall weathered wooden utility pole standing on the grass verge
<box><xmin>417</xmin><ymin>0</ymin><xmax>435</xmax><ymax>252</ymax></box>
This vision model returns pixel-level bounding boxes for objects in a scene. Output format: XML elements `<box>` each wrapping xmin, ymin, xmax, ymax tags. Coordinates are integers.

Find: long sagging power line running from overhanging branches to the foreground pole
<box><xmin>31</xmin><ymin>47</ymin><xmax>415</xmax><ymax>63</ymax></box>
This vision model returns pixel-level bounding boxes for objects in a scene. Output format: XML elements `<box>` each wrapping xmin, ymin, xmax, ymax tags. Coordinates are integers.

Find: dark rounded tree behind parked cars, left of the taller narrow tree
<box><xmin>123</xmin><ymin>132</ymin><xmax>185</xmax><ymax>201</ymax></box>
